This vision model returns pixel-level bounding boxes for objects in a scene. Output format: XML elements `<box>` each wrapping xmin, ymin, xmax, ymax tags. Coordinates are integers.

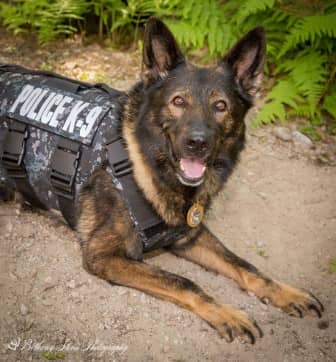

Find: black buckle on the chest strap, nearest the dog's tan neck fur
<box><xmin>106</xmin><ymin>137</ymin><xmax>132</xmax><ymax>177</ymax></box>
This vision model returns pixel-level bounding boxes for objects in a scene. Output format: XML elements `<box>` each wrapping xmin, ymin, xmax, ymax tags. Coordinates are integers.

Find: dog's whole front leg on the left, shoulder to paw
<box><xmin>77</xmin><ymin>171</ymin><xmax>261</xmax><ymax>343</ymax></box>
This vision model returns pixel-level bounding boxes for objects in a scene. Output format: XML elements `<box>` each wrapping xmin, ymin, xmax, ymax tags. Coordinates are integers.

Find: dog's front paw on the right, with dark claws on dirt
<box><xmin>260</xmin><ymin>282</ymin><xmax>324</xmax><ymax>318</ymax></box>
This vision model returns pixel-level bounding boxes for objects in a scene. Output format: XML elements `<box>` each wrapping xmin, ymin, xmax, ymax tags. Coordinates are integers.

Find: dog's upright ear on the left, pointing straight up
<box><xmin>142</xmin><ymin>17</ymin><xmax>185</xmax><ymax>84</ymax></box>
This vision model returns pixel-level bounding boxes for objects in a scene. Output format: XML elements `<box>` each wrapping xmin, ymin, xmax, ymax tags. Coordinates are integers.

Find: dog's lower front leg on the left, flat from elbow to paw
<box><xmin>84</xmin><ymin>247</ymin><xmax>262</xmax><ymax>343</ymax></box>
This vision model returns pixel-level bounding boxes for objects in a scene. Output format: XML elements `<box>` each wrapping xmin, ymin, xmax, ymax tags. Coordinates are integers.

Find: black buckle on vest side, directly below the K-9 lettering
<box><xmin>50</xmin><ymin>139</ymin><xmax>80</xmax><ymax>200</ymax></box>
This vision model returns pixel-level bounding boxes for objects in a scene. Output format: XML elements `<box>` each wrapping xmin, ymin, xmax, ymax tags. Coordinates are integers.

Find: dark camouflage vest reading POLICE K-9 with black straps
<box><xmin>0</xmin><ymin>65</ymin><xmax>188</xmax><ymax>251</ymax></box>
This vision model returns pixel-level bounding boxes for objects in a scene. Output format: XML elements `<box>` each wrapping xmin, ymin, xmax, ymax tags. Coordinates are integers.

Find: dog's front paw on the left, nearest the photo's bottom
<box><xmin>201</xmin><ymin>304</ymin><xmax>263</xmax><ymax>344</ymax></box>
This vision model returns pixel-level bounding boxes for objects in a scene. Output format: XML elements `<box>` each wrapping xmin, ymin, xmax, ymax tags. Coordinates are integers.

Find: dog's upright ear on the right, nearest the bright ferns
<box><xmin>219</xmin><ymin>27</ymin><xmax>266</xmax><ymax>96</ymax></box>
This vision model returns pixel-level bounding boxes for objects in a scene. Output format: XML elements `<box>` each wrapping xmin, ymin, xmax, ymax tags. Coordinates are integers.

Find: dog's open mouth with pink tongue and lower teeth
<box><xmin>177</xmin><ymin>158</ymin><xmax>206</xmax><ymax>187</ymax></box>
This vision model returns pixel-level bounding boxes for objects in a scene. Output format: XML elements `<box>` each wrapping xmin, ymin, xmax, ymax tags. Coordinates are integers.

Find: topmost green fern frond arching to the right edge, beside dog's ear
<box><xmin>279</xmin><ymin>13</ymin><xmax>336</xmax><ymax>57</ymax></box>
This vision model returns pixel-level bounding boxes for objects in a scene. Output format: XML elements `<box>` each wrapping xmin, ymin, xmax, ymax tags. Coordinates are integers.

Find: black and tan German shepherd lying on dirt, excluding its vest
<box><xmin>2</xmin><ymin>18</ymin><xmax>323</xmax><ymax>343</ymax></box>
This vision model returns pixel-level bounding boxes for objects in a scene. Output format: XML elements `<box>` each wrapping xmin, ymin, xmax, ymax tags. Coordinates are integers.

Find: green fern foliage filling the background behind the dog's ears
<box><xmin>0</xmin><ymin>0</ymin><xmax>336</xmax><ymax>133</ymax></box>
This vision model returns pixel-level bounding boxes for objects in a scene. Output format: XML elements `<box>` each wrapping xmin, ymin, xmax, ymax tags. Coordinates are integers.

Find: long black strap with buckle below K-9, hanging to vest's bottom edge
<box><xmin>50</xmin><ymin>137</ymin><xmax>81</xmax><ymax>228</ymax></box>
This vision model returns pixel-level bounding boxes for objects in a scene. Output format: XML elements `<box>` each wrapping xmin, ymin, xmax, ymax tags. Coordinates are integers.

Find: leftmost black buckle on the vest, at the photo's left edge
<box><xmin>2</xmin><ymin>121</ymin><xmax>28</xmax><ymax>178</ymax></box>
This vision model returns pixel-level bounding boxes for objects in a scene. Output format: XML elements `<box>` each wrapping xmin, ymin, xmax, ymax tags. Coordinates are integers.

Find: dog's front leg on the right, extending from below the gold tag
<box><xmin>171</xmin><ymin>227</ymin><xmax>323</xmax><ymax>317</ymax></box>
